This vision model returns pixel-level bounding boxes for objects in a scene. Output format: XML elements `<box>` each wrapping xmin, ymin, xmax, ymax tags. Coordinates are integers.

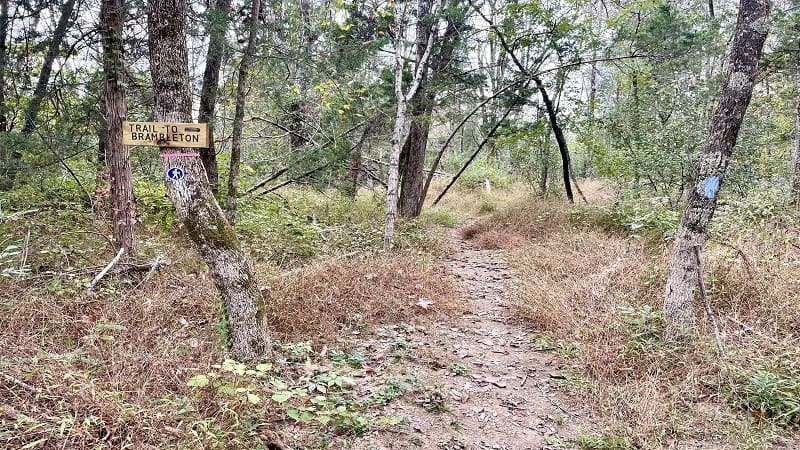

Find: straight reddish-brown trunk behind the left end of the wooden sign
<box><xmin>100</xmin><ymin>0</ymin><xmax>136</xmax><ymax>254</ymax></box>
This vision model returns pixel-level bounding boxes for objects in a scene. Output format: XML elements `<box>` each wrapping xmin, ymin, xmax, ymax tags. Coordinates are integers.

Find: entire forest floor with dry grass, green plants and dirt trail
<box><xmin>0</xmin><ymin>184</ymin><xmax>800</xmax><ymax>450</ymax></box>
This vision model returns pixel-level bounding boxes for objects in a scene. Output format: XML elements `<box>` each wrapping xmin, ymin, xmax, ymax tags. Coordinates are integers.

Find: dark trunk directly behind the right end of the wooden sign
<box><xmin>198</xmin><ymin>0</ymin><xmax>231</xmax><ymax>197</ymax></box>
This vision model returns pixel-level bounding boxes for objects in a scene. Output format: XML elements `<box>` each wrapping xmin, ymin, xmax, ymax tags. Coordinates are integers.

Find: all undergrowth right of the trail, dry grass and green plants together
<box><xmin>464</xmin><ymin>183</ymin><xmax>800</xmax><ymax>448</ymax></box>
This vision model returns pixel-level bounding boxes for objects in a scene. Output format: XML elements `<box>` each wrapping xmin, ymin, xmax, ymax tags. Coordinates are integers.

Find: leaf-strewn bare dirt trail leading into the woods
<box><xmin>353</xmin><ymin>230</ymin><xmax>593</xmax><ymax>450</ymax></box>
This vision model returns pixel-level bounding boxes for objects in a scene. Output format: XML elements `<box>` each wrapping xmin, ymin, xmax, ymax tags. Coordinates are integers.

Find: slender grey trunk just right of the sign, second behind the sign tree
<box><xmin>225</xmin><ymin>0</ymin><xmax>261</xmax><ymax>225</ymax></box>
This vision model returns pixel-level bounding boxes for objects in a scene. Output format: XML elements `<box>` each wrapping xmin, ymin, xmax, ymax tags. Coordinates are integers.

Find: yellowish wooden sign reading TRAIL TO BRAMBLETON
<box><xmin>122</xmin><ymin>121</ymin><xmax>208</xmax><ymax>148</ymax></box>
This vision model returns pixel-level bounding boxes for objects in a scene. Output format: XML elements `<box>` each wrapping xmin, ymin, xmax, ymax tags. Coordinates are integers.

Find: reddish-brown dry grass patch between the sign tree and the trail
<box><xmin>263</xmin><ymin>256</ymin><xmax>463</xmax><ymax>342</ymax></box>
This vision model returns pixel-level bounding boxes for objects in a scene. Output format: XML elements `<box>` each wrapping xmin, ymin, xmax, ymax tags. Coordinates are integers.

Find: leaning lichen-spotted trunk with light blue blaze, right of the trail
<box><xmin>664</xmin><ymin>0</ymin><xmax>770</xmax><ymax>337</ymax></box>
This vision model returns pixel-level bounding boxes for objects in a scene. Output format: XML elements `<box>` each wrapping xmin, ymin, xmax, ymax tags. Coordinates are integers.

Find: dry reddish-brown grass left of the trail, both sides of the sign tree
<box><xmin>0</xmin><ymin>198</ymin><xmax>461</xmax><ymax>449</ymax></box>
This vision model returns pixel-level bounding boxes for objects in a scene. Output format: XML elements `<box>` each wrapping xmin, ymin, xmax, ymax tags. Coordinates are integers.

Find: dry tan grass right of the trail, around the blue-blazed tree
<box><xmin>464</xmin><ymin>191</ymin><xmax>800</xmax><ymax>448</ymax></box>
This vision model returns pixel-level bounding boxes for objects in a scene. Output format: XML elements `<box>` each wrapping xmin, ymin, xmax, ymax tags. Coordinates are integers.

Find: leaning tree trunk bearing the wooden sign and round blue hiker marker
<box><xmin>147</xmin><ymin>0</ymin><xmax>270</xmax><ymax>361</ymax></box>
